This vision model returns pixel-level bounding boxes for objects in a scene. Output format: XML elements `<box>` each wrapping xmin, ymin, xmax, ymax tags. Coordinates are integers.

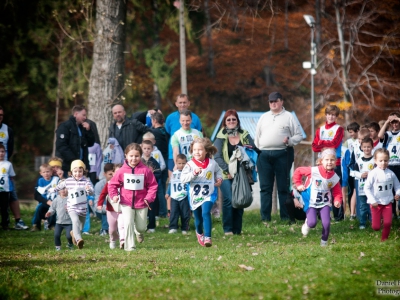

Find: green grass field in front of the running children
<box><xmin>0</xmin><ymin>209</ymin><xmax>400</xmax><ymax>299</ymax></box>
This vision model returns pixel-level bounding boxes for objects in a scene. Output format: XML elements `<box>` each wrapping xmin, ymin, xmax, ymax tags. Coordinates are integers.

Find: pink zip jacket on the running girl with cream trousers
<box><xmin>108</xmin><ymin>161</ymin><xmax>158</xmax><ymax>209</ymax></box>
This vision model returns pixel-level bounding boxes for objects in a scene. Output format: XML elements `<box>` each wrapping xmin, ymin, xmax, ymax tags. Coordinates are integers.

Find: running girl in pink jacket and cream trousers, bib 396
<box><xmin>108</xmin><ymin>143</ymin><xmax>157</xmax><ymax>251</ymax></box>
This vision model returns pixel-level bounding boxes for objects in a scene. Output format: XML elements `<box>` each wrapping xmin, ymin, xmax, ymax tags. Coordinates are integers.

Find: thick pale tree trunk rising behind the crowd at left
<box><xmin>88</xmin><ymin>0</ymin><xmax>126</xmax><ymax>148</ymax></box>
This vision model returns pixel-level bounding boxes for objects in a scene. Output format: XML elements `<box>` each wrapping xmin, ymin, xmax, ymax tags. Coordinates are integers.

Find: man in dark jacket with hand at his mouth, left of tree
<box><xmin>56</xmin><ymin>105</ymin><xmax>95</xmax><ymax>177</ymax></box>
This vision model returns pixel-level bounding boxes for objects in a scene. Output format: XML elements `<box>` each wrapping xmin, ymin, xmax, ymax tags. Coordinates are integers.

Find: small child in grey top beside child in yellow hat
<box><xmin>46</xmin><ymin>189</ymin><xmax>74</xmax><ymax>251</ymax></box>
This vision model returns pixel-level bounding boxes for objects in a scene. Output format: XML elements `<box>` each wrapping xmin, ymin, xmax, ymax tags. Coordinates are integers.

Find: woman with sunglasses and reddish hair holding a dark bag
<box><xmin>214</xmin><ymin>109</ymin><xmax>256</xmax><ymax>235</ymax></box>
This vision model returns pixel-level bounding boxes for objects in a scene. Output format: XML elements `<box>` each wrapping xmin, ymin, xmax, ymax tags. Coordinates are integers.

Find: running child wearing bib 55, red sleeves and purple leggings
<box><xmin>293</xmin><ymin>148</ymin><xmax>343</xmax><ymax>247</ymax></box>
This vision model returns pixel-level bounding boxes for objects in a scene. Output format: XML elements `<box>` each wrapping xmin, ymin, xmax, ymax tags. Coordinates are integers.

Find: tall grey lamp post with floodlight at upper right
<box><xmin>303</xmin><ymin>15</ymin><xmax>317</xmax><ymax>165</ymax></box>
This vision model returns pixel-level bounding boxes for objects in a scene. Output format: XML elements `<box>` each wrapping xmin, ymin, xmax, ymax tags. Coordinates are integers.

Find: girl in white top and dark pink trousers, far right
<box><xmin>364</xmin><ymin>148</ymin><xmax>400</xmax><ymax>242</ymax></box>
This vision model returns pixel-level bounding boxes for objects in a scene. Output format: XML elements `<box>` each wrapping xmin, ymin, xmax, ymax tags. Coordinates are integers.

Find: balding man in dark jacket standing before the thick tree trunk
<box><xmin>108</xmin><ymin>104</ymin><xmax>149</xmax><ymax>150</ymax></box>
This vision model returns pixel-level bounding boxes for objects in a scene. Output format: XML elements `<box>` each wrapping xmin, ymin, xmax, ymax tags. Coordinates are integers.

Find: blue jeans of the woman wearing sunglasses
<box><xmin>221</xmin><ymin>179</ymin><xmax>244</xmax><ymax>234</ymax></box>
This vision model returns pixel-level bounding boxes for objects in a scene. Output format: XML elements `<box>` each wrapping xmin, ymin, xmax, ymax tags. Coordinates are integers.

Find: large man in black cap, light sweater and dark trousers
<box><xmin>254</xmin><ymin>92</ymin><xmax>303</xmax><ymax>222</ymax></box>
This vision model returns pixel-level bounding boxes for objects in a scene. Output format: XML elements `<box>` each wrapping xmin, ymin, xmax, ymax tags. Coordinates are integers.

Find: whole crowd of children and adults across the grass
<box><xmin>0</xmin><ymin>92</ymin><xmax>400</xmax><ymax>251</ymax></box>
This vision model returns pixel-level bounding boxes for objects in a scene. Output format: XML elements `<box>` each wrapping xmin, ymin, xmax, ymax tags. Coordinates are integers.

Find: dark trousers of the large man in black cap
<box><xmin>257</xmin><ymin>147</ymin><xmax>293</xmax><ymax>221</ymax></box>
